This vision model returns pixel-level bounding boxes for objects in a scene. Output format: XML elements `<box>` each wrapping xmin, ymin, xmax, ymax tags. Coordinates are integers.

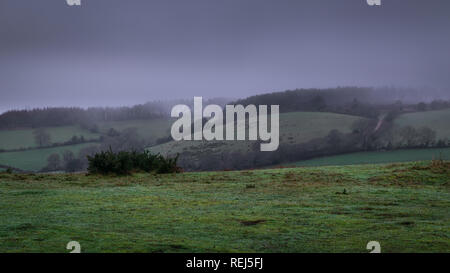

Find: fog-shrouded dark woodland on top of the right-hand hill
<box><xmin>232</xmin><ymin>87</ymin><xmax>450</xmax><ymax>118</ymax></box>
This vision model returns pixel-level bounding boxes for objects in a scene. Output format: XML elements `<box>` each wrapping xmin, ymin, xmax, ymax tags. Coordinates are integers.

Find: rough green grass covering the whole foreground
<box><xmin>0</xmin><ymin>162</ymin><xmax>450</xmax><ymax>252</ymax></box>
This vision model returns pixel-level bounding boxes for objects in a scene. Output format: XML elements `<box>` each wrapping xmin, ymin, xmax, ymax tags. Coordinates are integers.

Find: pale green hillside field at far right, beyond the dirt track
<box><xmin>395</xmin><ymin>109</ymin><xmax>450</xmax><ymax>139</ymax></box>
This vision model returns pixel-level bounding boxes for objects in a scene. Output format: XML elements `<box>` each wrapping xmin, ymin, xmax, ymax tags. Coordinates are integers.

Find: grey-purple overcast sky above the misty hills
<box><xmin>0</xmin><ymin>0</ymin><xmax>450</xmax><ymax>111</ymax></box>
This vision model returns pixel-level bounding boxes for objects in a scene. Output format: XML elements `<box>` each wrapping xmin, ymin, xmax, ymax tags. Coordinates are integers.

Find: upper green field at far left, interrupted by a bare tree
<box><xmin>0</xmin><ymin>126</ymin><xmax>100</xmax><ymax>150</ymax></box>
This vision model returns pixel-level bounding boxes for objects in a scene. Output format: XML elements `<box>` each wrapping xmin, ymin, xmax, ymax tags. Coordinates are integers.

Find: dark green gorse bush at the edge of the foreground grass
<box><xmin>88</xmin><ymin>149</ymin><xmax>180</xmax><ymax>175</ymax></box>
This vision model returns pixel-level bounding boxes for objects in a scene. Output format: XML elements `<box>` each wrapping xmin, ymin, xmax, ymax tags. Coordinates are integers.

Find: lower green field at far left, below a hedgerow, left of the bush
<box><xmin>0</xmin><ymin>143</ymin><xmax>95</xmax><ymax>171</ymax></box>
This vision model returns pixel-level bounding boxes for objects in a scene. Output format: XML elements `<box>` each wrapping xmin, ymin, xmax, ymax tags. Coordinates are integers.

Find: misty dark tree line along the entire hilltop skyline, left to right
<box><xmin>0</xmin><ymin>87</ymin><xmax>450</xmax><ymax>131</ymax></box>
